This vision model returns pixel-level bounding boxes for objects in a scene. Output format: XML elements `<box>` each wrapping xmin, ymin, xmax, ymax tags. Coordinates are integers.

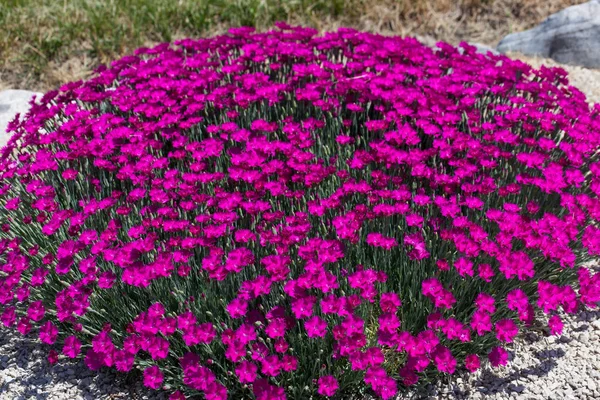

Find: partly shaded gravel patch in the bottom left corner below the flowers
<box><xmin>0</xmin><ymin>329</ymin><xmax>167</xmax><ymax>400</ymax></box>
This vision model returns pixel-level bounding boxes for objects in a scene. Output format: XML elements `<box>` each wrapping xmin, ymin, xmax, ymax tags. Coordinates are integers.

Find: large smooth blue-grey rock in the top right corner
<box><xmin>497</xmin><ymin>0</ymin><xmax>600</xmax><ymax>68</ymax></box>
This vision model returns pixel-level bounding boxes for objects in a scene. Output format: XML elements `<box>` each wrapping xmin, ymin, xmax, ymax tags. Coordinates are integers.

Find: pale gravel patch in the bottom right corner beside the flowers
<box><xmin>406</xmin><ymin>284</ymin><xmax>600</xmax><ymax>400</ymax></box>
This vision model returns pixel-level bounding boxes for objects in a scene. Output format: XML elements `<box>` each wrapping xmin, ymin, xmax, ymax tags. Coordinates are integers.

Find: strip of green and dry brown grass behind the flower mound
<box><xmin>0</xmin><ymin>0</ymin><xmax>585</xmax><ymax>91</ymax></box>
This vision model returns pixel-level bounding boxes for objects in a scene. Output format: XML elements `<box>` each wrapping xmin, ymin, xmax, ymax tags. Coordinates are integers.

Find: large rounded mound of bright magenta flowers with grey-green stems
<box><xmin>0</xmin><ymin>24</ymin><xmax>600</xmax><ymax>399</ymax></box>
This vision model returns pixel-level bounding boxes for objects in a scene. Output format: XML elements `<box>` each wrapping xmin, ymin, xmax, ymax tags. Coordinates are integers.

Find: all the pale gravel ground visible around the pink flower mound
<box><xmin>0</xmin><ymin>55</ymin><xmax>600</xmax><ymax>400</ymax></box>
